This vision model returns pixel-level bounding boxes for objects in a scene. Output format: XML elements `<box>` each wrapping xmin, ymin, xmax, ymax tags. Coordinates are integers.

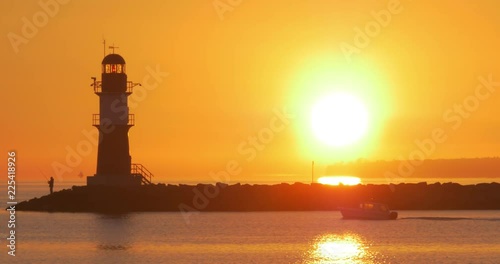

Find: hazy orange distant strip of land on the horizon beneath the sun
<box><xmin>327</xmin><ymin>157</ymin><xmax>500</xmax><ymax>178</ymax></box>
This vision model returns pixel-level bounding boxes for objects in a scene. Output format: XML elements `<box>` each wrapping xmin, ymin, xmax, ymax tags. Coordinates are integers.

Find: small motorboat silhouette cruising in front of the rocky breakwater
<box><xmin>339</xmin><ymin>202</ymin><xmax>398</xmax><ymax>220</ymax></box>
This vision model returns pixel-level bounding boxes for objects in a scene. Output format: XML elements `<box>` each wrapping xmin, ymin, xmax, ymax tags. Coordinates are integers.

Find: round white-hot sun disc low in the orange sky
<box><xmin>311</xmin><ymin>92</ymin><xmax>368</xmax><ymax>147</ymax></box>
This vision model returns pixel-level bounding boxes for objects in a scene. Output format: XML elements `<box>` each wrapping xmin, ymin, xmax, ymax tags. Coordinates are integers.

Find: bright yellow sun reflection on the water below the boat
<box><xmin>308</xmin><ymin>234</ymin><xmax>375</xmax><ymax>264</ymax></box>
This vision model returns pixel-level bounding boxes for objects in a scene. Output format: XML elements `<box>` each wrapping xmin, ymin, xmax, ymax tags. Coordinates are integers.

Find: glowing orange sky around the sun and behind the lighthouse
<box><xmin>0</xmin><ymin>0</ymin><xmax>500</xmax><ymax>182</ymax></box>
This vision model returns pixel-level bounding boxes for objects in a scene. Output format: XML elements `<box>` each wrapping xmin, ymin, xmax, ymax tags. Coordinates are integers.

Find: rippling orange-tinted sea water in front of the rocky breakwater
<box><xmin>0</xmin><ymin>180</ymin><xmax>500</xmax><ymax>264</ymax></box>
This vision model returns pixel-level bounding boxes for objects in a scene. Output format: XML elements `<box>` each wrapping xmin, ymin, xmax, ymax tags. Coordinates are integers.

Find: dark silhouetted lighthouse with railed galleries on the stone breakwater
<box><xmin>87</xmin><ymin>47</ymin><xmax>153</xmax><ymax>186</ymax></box>
